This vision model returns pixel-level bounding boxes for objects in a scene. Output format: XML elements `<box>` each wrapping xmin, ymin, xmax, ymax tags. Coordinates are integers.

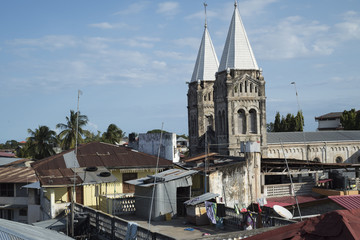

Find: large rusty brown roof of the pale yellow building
<box><xmin>32</xmin><ymin>142</ymin><xmax>172</xmax><ymax>171</ymax></box>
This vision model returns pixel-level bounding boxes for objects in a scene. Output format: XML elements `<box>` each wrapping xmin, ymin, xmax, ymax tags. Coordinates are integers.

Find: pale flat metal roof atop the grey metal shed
<box><xmin>126</xmin><ymin>169</ymin><xmax>197</xmax><ymax>187</ymax></box>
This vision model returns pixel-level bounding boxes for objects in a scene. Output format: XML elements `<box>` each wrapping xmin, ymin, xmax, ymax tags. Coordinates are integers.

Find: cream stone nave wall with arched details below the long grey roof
<box><xmin>268</xmin><ymin>142</ymin><xmax>360</xmax><ymax>163</ymax></box>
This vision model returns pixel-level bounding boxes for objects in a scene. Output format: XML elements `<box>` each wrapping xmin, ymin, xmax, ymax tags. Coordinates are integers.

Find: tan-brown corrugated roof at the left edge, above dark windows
<box><xmin>0</xmin><ymin>167</ymin><xmax>38</xmax><ymax>183</ymax></box>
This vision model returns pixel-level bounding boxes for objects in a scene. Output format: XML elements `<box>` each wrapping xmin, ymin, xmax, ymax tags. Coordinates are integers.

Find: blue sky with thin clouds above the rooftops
<box><xmin>0</xmin><ymin>0</ymin><xmax>360</xmax><ymax>143</ymax></box>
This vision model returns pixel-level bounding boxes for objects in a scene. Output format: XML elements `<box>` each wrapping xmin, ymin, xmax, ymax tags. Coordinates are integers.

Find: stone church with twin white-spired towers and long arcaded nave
<box><xmin>187</xmin><ymin>3</ymin><xmax>360</xmax><ymax>163</ymax></box>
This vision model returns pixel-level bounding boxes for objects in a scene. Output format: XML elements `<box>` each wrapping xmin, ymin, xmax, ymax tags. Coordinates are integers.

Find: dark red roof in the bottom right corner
<box><xmin>246</xmin><ymin>209</ymin><xmax>360</xmax><ymax>240</ymax></box>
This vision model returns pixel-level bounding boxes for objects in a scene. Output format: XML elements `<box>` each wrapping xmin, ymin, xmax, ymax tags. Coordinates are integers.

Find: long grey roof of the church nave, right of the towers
<box><xmin>267</xmin><ymin>131</ymin><xmax>360</xmax><ymax>144</ymax></box>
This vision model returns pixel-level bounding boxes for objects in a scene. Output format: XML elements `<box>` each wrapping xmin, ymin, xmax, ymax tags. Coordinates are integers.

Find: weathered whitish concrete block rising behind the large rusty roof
<box><xmin>139</xmin><ymin>133</ymin><xmax>180</xmax><ymax>162</ymax></box>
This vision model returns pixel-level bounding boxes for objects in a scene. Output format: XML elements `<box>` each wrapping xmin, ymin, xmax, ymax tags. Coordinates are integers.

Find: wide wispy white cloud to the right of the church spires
<box><xmin>250</xmin><ymin>11</ymin><xmax>360</xmax><ymax>59</ymax></box>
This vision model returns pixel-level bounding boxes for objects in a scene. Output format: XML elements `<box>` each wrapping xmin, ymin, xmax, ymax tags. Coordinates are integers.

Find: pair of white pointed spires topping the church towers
<box><xmin>191</xmin><ymin>2</ymin><xmax>259</xmax><ymax>82</ymax></box>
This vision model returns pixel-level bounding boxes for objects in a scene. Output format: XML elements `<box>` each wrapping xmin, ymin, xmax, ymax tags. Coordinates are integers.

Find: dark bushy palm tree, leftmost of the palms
<box><xmin>26</xmin><ymin>126</ymin><xmax>57</xmax><ymax>159</ymax></box>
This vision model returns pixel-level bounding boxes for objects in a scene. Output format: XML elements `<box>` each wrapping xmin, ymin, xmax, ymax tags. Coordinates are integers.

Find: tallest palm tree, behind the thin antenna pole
<box><xmin>56</xmin><ymin>110</ymin><xmax>88</xmax><ymax>150</ymax></box>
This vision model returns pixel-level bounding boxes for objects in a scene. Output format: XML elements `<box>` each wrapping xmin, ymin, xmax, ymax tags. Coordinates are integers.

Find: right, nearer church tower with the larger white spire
<box><xmin>213</xmin><ymin>2</ymin><xmax>267</xmax><ymax>156</ymax></box>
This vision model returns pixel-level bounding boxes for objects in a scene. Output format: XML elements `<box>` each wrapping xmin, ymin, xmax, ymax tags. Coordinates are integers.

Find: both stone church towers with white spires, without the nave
<box><xmin>188</xmin><ymin>3</ymin><xmax>266</xmax><ymax>156</ymax></box>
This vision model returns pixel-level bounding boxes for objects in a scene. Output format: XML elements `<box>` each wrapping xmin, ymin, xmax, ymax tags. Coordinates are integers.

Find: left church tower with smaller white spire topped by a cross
<box><xmin>187</xmin><ymin>4</ymin><xmax>219</xmax><ymax>155</ymax></box>
